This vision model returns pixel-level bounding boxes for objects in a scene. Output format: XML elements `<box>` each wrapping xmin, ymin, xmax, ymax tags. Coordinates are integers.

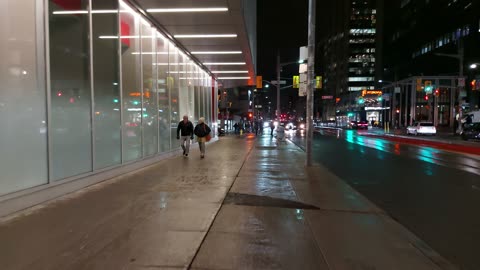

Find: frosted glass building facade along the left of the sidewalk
<box><xmin>0</xmin><ymin>0</ymin><xmax>218</xmax><ymax>199</ymax></box>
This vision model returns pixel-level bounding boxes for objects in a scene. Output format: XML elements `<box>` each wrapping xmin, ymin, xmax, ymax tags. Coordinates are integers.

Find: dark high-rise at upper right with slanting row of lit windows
<box><xmin>384</xmin><ymin>0</ymin><xmax>480</xmax><ymax>110</ymax></box>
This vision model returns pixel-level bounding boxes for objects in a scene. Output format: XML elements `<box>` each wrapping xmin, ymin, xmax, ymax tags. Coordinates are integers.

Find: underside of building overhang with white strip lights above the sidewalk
<box><xmin>133</xmin><ymin>0</ymin><xmax>255</xmax><ymax>87</ymax></box>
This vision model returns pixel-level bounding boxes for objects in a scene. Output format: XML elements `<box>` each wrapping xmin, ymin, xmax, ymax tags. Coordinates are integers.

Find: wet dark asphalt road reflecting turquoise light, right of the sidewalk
<box><xmin>290</xmin><ymin>130</ymin><xmax>480</xmax><ymax>270</ymax></box>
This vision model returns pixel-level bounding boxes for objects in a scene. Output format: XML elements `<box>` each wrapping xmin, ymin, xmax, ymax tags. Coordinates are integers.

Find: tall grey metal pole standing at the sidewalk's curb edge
<box><xmin>305</xmin><ymin>0</ymin><xmax>316</xmax><ymax>167</ymax></box>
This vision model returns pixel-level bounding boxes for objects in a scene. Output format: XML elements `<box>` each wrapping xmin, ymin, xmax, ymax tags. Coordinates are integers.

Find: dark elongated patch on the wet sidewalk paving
<box><xmin>224</xmin><ymin>192</ymin><xmax>319</xmax><ymax>209</ymax></box>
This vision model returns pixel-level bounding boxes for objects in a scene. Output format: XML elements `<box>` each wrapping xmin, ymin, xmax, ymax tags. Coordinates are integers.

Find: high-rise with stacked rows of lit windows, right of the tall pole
<box><xmin>319</xmin><ymin>0</ymin><xmax>383</xmax><ymax>125</ymax></box>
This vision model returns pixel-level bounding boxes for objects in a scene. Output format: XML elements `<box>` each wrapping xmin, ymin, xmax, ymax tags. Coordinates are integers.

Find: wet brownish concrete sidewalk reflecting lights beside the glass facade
<box><xmin>0</xmin><ymin>134</ymin><xmax>455</xmax><ymax>270</ymax></box>
